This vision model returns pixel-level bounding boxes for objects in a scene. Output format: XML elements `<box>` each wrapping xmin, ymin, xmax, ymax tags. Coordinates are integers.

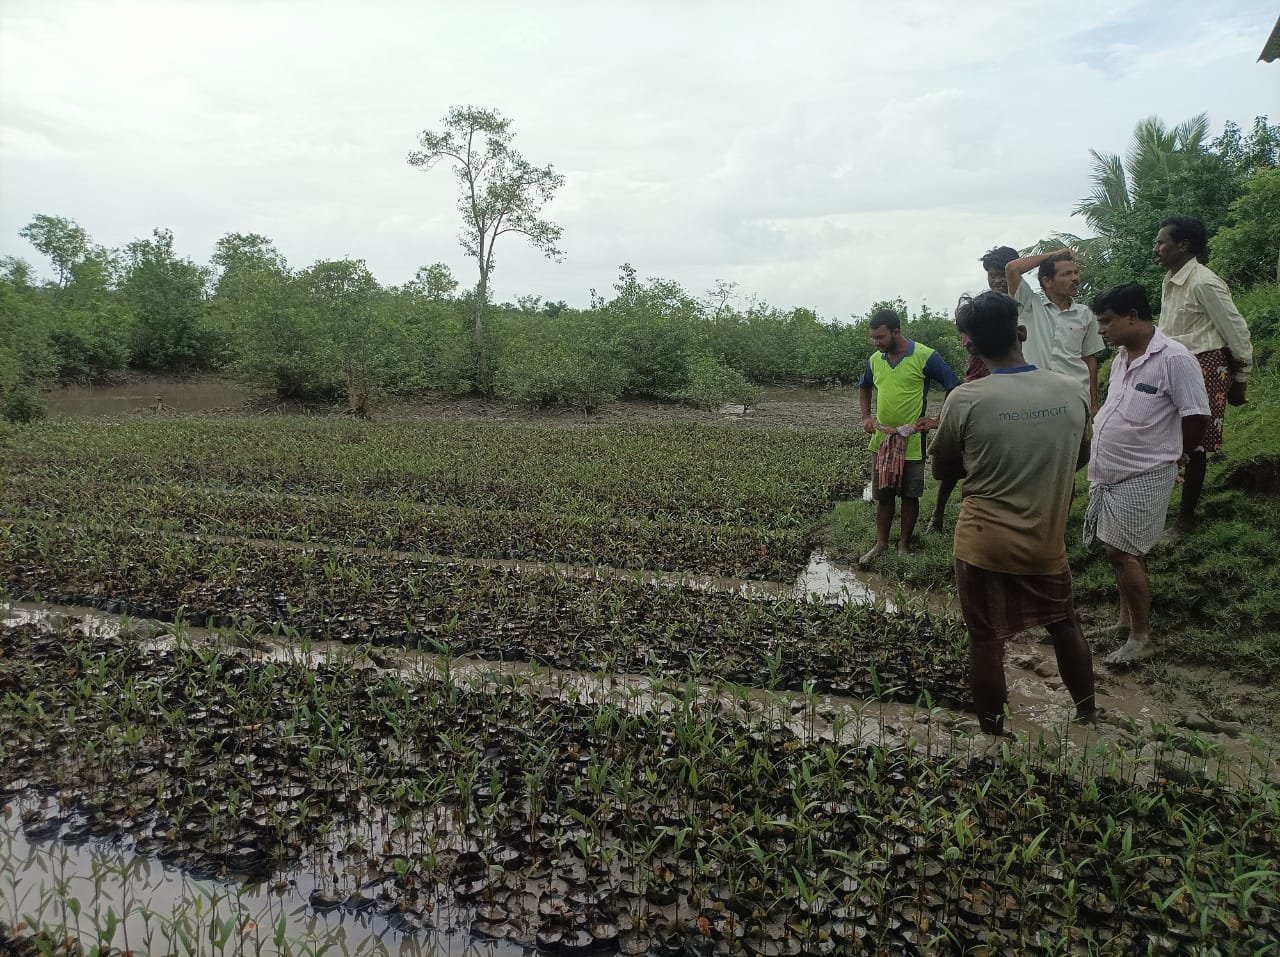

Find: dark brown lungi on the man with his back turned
<box><xmin>955</xmin><ymin>558</ymin><xmax>1075</xmax><ymax>641</ymax></box>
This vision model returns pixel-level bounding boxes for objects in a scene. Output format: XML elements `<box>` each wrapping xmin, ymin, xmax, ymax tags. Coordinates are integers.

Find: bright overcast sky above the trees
<box><xmin>0</xmin><ymin>0</ymin><xmax>1280</xmax><ymax>319</ymax></box>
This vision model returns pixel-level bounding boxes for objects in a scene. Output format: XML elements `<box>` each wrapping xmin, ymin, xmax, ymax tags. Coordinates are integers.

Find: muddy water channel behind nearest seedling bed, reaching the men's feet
<box><xmin>0</xmin><ymin>591</ymin><xmax>1280</xmax><ymax>782</ymax></box>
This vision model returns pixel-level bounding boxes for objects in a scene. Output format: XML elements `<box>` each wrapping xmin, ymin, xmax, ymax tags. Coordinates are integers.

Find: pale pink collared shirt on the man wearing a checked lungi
<box><xmin>1089</xmin><ymin>329</ymin><xmax>1210</xmax><ymax>484</ymax></box>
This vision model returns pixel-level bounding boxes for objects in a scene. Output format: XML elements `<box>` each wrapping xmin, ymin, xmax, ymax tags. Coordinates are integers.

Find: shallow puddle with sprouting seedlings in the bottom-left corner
<box><xmin>0</xmin><ymin>812</ymin><xmax>526</xmax><ymax>957</ymax></box>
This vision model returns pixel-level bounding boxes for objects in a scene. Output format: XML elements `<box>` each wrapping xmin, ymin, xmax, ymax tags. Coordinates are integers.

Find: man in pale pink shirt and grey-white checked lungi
<box><xmin>1084</xmin><ymin>283</ymin><xmax>1210</xmax><ymax>664</ymax></box>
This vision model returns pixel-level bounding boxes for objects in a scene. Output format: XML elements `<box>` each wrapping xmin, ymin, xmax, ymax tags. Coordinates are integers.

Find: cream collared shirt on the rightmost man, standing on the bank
<box><xmin>1160</xmin><ymin>260</ymin><xmax>1253</xmax><ymax>383</ymax></box>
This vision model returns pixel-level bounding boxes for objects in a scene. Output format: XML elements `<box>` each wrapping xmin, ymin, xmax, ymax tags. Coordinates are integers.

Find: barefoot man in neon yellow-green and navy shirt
<box><xmin>858</xmin><ymin>310</ymin><xmax>960</xmax><ymax>564</ymax></box>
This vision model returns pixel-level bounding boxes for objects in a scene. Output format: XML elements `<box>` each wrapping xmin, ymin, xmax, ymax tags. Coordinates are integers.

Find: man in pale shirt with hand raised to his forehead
<box><xmin>1005</xmin><ymin>248</ymin><xmax>1103</xmax><ymax>415</ymax></box>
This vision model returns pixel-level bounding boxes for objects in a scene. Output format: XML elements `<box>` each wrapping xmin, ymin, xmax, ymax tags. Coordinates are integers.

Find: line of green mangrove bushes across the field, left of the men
<box><xmin>0</xmin><ymin>223</ymin><xmax>963</xmax><ymax>419</ymax></box>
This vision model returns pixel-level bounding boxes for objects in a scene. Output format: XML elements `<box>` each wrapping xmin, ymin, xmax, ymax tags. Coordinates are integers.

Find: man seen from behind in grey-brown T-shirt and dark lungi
<box><xmin>933</xmin><ymin>292</ymin><xmax>1094</xmax><ymax>734</ymax></box>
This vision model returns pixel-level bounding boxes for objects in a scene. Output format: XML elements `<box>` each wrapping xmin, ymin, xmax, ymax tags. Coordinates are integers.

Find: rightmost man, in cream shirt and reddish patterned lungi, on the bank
<box><xmin>1155</xmin><ymin>216</ymin><xmax>1253</xmax><ymax>539</ymax></box>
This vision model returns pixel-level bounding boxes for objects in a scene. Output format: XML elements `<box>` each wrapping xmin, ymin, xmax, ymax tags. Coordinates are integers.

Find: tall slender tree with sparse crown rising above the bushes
<box><xmin>408</xmin><ymin>106</ymin><xmax>564</xmax><ymax>394</ymax></box>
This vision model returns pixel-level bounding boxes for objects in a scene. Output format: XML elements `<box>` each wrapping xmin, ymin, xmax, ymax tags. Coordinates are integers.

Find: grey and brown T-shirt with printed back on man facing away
<box><xmin>934</xmin><ymin>368</ymin><xmax>1088</xmax><ymax>574</ymax></box>
